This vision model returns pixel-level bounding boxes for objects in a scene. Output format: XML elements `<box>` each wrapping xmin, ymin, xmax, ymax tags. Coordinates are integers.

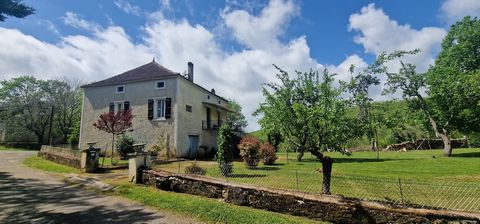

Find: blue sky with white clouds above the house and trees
<box><xmin>0</xmin><ymin>0</ymin><xmax>480</xmax><ymax>131</ymax></box>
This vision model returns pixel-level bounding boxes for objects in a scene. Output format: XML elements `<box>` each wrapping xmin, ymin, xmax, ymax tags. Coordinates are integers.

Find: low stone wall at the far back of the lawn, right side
<box><xmin>384</xmin><ymin>138</ymin><xmax>468</xmax><ymax>151</ymax></box>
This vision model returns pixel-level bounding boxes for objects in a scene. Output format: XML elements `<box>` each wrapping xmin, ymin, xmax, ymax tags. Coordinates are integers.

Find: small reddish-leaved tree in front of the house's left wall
<box><xmin>93</xmin><ymin>109</ymin><xmax>134</xmax><ymax>163</ymax></box>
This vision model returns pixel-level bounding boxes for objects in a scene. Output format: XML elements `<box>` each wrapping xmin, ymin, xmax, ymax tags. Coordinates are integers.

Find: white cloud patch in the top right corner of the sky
<box><xmin>441</xmin><ymin>0</ymin><xmax>480</xmax><ymax>23</ymax></box>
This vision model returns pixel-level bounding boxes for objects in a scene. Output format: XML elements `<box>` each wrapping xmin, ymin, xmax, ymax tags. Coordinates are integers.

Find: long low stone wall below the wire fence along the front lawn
<box><xmin>144</xmin><ymin>170</ymin><xmax>480</xmax><ymax>224</ymax></box>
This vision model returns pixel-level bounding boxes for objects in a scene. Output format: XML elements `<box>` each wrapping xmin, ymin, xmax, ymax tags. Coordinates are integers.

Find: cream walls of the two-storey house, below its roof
<box><xmin>79</xmin><ymin>62</ymin><xmax>228</xmax><ymax>158</ymax></box>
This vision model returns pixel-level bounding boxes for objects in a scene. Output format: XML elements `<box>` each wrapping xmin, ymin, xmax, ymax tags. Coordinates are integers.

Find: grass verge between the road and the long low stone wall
<box><xmin>113</xmin><ymin>184</ymin><xmax>319</xmax><ymax>224</ymax></box>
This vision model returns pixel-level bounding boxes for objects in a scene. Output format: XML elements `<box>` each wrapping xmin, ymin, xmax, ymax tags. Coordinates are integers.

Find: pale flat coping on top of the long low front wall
<box><xmin>145</xmin><ymin>170</ymin><xmax>480</xmax><ymax>221</ymax></box>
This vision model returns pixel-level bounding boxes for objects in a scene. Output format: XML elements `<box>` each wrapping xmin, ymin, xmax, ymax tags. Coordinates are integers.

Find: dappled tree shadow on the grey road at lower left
<box><xmin>0</xmin><ymin>172</ymin><xmax>163</xmax><ymax>224</ymax></box>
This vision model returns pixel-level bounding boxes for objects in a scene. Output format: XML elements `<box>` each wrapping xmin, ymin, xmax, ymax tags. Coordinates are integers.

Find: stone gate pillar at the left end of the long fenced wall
<box><xmin>128</xmin><ymin>152</ymin><xmax>151</xmax><ymax>183</ymax></box>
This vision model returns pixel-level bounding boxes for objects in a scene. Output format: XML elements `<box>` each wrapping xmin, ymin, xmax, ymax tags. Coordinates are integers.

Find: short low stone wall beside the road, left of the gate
<box><xmin>38</xmin><ymin>145</ymin><xmax>82</xmax><ymax>169</ymax></box>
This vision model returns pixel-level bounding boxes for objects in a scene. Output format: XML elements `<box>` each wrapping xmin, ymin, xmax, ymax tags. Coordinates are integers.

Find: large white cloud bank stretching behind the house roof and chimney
<box><xmin>0</xmin><ymin>0</ymin><xmax>376</xmax><ymax>130</ymax></box>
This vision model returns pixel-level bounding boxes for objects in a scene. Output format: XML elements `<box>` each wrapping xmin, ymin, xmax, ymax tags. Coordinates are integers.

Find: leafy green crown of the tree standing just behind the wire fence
<box><xmin>255</xmin><ymin>66</ymin><xmax>358</xmax><ymax>161</ymax></box>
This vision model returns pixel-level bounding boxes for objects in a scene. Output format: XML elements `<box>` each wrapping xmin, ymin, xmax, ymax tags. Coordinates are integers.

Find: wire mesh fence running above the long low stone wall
<box><xmin>155</xmin><ymin>161</ymin><xmax>480</xmax><ymax>212</ymax></box>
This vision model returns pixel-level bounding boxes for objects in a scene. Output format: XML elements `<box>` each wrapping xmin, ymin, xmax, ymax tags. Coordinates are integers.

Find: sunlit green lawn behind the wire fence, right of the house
<box><xmin>158</xmin><ymin>149</ymin><xmax>480</xmax><ymax>211</ymax></box>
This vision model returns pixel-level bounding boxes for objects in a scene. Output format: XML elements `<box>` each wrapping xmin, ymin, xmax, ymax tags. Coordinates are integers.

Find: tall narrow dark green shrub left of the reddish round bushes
<box><xmin>217</xmin><ymin>124</ymin><xmax>234</xmax><ymax>176</ymax></box>
